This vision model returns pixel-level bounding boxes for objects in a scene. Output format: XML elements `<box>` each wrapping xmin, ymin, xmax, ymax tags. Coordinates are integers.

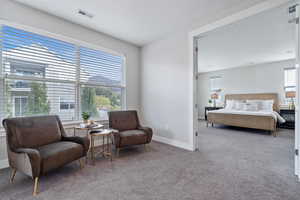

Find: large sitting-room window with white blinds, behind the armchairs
<box><xmin>0</xmin><ymin>25</ymin><xmax>125</xmax><ymax>120</ymax></box>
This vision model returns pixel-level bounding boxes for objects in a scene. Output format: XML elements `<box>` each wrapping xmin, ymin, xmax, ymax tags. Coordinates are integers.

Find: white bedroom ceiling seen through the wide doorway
<box><xmin>198</xmin><ymin>5</ymin><xmax>296</xmax><ymax>72</ymax></box>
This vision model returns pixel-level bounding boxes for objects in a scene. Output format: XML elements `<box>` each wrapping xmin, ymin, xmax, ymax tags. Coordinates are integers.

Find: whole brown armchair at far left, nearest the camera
<box><xmin>2</xmin><ymin>116</ymin><xmax>89</xmax><ymax>195</ymax></box>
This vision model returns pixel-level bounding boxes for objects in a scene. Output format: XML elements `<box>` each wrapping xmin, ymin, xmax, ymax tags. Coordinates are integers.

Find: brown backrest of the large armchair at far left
<box><xmin>2</xmin><ymin>116</ymin><xmax>64</xmax><ymax>148</ymax></box>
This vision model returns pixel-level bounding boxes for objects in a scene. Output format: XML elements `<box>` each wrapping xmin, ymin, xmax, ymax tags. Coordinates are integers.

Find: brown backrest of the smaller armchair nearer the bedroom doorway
<box><xmin>108</xmin><ymin>110</ymin><xmax>139</xmax><ymax>131</ymax></box>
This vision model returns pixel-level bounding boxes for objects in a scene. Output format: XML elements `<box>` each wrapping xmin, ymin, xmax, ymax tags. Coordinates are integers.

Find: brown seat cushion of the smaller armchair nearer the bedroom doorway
<box><xmin>119</xmin><ymin>130</ymin><xmax>148</xmax><ymax>146</ymax></box>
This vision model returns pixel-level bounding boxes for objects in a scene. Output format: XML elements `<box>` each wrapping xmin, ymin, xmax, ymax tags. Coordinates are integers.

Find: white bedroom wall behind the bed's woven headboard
<box><xmin>198</xmin><ymin>60</ymin><xmax>295</xmax><ymax>119</ymax></box>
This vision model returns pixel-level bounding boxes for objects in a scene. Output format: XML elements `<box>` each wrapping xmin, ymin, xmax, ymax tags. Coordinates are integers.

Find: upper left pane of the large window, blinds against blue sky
<box><xmin>2</xmin><ymin>26</ymin><xmax>76</xmax><ymax>81</ymax></box>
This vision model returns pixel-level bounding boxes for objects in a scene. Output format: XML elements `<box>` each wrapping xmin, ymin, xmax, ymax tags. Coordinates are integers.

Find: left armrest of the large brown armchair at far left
<box><xmin>10</xmin><ymin>148</ymin><xmax>41</xmax><ymax>178</ymax></box>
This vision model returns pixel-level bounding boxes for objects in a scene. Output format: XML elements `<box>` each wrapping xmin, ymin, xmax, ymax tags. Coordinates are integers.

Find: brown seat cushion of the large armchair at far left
<box><xmin>37</xmin><ymin>141</ymin><xmax>84</xmax><ymax>174</ymax></box>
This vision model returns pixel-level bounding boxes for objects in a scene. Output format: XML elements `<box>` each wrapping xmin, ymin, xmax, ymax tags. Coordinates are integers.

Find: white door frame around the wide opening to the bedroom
<box><xmin>188</xmin><ymin>0</ymin><xmax>300</xmax><ymax>179</ymax></box>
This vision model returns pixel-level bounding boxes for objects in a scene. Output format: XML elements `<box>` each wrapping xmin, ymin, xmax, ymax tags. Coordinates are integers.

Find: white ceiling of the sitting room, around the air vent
<box><xmin>15</xmin><ymin>0</ymin><xmax>262</xmax><ymax>46</ymax></box>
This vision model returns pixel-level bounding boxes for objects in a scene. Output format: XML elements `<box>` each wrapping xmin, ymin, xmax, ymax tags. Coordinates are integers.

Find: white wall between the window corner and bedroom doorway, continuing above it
<box><xmin>141</xmin><ymin>0</ymin><xmax>270</xmax><ymax>149</ymax></box>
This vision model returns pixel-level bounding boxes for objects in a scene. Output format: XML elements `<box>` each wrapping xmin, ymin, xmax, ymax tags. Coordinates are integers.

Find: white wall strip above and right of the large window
<box><xmin>0</xmin><ymin>0</ymin><xmax>140</xmax><ymax>110</ymax></box>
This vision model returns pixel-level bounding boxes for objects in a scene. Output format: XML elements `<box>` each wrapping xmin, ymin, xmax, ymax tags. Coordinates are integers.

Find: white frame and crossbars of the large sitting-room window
<box><xmin>0</xmin><ymin>19</ymin><xmax>127</xmax><ymax>121</ymax></box>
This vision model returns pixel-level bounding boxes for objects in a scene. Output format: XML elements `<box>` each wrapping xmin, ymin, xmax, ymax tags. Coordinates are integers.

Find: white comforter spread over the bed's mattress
<box><xmin>208</xmin><ymin>109</ymin><xmax>285</xmax><ymax>123</ymax></box>
